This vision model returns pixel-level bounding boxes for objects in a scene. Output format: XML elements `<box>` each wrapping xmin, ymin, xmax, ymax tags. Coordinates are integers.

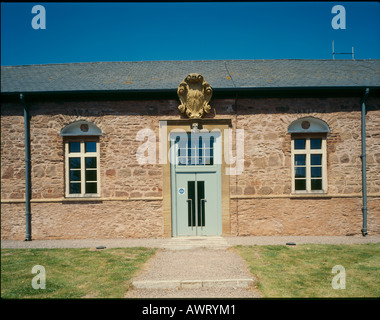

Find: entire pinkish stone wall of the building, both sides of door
<box><xmin>1</xmin><ymin>98</ymin><xmax>380</xmax><ymax>239</ymax></box>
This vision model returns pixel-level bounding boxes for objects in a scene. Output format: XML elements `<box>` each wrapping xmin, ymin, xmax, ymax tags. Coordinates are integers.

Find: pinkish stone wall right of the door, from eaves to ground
<box><xmin>226</xmin><ymin>98</ymin><xmax>380</xmax><ymax>235</ymax></box>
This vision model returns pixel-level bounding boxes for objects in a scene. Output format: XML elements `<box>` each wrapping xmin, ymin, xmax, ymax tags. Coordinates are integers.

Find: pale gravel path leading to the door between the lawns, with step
<box><xmin>126</xmin><ymin>246</ymin><xmax>261</xmax><ymax>298</ymax></box>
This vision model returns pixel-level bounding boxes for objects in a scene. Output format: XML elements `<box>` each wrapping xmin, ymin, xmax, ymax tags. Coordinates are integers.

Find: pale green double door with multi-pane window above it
<box><xmin>171</xmin><ymin>133</ymin><xmax>222</xmax><ymax>236</ymax></box>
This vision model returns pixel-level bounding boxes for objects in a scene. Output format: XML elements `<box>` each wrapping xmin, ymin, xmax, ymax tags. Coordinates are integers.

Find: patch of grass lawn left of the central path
<box><xmin>1</xmin><ymin>248</ymin><xmax>155</xmax><ymax>299</ymax></box>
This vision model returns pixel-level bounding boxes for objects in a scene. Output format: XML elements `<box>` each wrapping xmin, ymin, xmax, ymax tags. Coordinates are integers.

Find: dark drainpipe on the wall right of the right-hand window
<box><xmin>360</xmin><ymin>88</ymin><xmax>369</xmax><ymax>237</ymax></box>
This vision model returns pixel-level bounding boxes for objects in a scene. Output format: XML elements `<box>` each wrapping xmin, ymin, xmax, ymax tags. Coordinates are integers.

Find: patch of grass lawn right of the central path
<box><xmin>235</xmin><ymin>243</ymin><xmax>380</xmax><ymax>298</ymax></box>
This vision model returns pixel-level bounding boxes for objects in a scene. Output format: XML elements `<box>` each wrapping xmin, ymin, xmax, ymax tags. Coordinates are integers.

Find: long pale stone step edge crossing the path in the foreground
<box><xmin>132</xmin><ymin>278</ymin><xmax>254</xmax><ymax>289</ymax></box>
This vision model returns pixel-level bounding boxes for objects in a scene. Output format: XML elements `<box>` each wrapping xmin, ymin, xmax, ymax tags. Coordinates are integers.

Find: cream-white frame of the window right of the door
<box><xmin>291</xmin><ymin>134</ymin><xmax>327</xmax><ymax>194</ymax></box>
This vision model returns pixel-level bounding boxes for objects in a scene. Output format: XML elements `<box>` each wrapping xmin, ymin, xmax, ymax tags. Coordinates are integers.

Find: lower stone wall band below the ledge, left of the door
<box><xmin>1</xmin><ymin>200</ymin><xmax>163</xmax><ymax>240</ymax></box>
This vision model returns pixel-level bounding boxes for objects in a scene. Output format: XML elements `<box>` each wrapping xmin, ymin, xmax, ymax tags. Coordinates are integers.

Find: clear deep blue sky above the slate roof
<box><xmin>1</xmin><ymin>2</ymin><xmax>380</xmax><ymax>65</ymax></box>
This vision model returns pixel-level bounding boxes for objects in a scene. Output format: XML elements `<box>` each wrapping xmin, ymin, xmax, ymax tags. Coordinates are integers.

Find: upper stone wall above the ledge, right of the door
<box><xmin>231</xmin><ymin>98</ymin><xmax>380</xmax><ymax>195</ymax></box>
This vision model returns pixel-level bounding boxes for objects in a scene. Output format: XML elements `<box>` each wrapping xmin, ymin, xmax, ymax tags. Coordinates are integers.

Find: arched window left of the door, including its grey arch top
<box><xmin>61</xmin><ymin>120</ymin><xmax>102</xmax><ymax>198</ymax></box>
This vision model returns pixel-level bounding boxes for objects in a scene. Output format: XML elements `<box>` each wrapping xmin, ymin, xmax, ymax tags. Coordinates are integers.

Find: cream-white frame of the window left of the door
<box><xmin>65</xmin><ymin>137</ymin><xmax>100</xmax><ymax>198</ymax></box>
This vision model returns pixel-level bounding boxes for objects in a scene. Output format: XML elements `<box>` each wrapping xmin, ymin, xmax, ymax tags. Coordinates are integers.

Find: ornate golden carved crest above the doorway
<box><xmin>177</xmin><ymin>73</ymin><xmax>212</xmax><ymax>119</ymax></box>
